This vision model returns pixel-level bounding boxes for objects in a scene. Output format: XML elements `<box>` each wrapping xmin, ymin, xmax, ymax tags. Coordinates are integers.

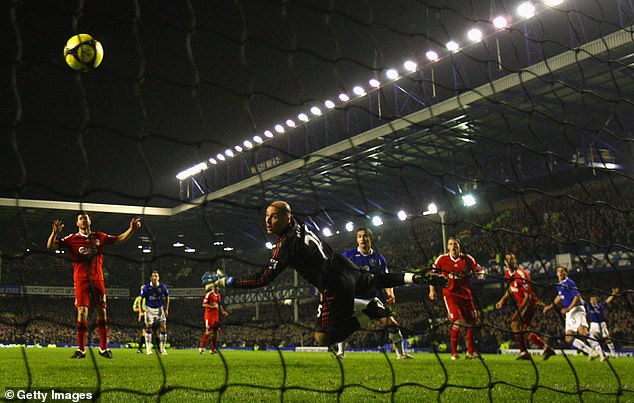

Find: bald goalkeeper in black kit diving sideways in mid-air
<box><xmin>201</xmin><ymin>201</ymin><xmax>448</xmax><ymax>346</ymax></box>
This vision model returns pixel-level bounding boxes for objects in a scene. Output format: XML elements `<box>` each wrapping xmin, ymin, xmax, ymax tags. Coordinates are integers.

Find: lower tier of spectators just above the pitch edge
<box><xmin>0</xmin><ymin>280</ymin><xmax>634</xmax><ymax>352</ymax></box>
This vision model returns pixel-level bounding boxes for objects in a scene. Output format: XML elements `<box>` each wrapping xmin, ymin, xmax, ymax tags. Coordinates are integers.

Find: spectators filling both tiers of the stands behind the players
<box><xmin>0</xmin><ymin>178</ymin><xmax>634</xmax><ymax>347</ymax></box>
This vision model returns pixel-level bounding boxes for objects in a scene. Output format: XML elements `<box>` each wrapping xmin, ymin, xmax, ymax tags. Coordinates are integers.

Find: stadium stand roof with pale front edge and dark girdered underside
<box><xmin>0</xmin><ymin>29</ymin><xmax>634</xmax><ymax>254</ymax></box>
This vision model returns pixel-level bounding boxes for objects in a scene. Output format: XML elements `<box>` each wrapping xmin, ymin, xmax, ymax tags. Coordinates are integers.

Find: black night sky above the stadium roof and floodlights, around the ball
<box><xmin>0</xmin><ymin>0</ymin><xmax>624</xmax><ymax>205</ymax></box>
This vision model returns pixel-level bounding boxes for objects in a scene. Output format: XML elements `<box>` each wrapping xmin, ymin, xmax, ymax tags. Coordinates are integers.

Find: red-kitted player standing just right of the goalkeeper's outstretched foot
<box><xmin>429</xmin><ymin>237</ymin><xmax>483</xmax><ymax>360</ymax></box>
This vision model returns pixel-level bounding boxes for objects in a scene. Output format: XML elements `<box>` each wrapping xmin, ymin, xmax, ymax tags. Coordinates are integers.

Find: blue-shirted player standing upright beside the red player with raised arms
<box><xmin>141</xmin><ymin>270</ymin><xmax>170</xmax><ymax>355</ymax></box>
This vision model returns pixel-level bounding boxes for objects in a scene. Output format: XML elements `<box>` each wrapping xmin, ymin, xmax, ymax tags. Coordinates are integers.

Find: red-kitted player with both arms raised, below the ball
<box><xmin>46</xmin><ymin>211</ymin><xmax>141</xmax><ymax>358</ymax></box>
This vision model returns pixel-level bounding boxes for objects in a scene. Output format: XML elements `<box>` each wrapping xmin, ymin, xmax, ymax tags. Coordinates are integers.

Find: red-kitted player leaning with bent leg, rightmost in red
<box><xmin>495</xmin><ymin>253</ymin><xmax>555</xmax><ymax>360</ymax></box>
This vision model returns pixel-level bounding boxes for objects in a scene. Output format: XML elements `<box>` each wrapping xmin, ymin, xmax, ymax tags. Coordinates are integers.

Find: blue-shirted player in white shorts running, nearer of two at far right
<box><xmin>544</xmin><ymin>266</ymin><xmax>605</xmax><ymax>361</ymax></box>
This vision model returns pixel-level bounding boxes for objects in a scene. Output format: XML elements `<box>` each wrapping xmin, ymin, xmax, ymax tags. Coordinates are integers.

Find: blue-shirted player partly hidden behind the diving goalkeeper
<box><xmin>337</xmin><ymin>228</ymin><xmax>413</xmax><ymax>360</ymax></box>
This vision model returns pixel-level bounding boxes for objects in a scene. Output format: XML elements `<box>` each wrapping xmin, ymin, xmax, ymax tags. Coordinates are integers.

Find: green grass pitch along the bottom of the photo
<box><xmin>0</xmin><ymin>348</ymin><xmax>634</xmax><ymax>403</ymax></box>
